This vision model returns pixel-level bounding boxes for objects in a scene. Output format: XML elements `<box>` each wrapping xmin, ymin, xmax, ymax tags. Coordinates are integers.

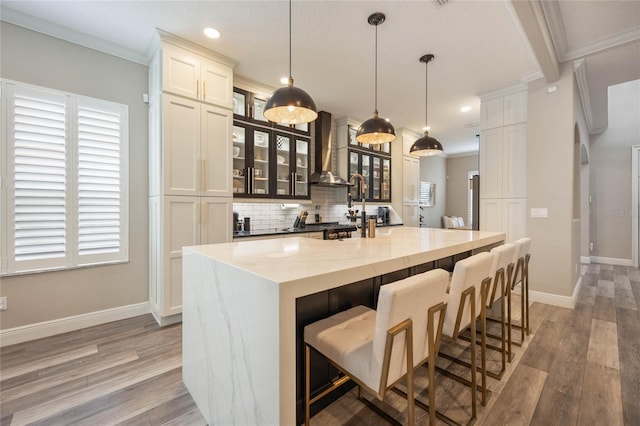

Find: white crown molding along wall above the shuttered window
<box><xmin>0</xmin><ymin>6</ymin><xmax>149</xmax><ymax>66</ymax></box>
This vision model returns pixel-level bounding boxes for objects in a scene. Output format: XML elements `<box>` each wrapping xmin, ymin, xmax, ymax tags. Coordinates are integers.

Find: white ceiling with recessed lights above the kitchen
<box><xmin>0</xmin><ymin>0</ymin><xmax>640</xmax><ymax>155</ymax></box>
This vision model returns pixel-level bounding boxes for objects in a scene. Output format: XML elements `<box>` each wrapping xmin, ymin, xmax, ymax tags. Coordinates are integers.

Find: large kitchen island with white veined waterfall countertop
<box><xmin>182</xmin><ymin>227</ymin><xmax>505</xmax><ymax>425</ymax></box>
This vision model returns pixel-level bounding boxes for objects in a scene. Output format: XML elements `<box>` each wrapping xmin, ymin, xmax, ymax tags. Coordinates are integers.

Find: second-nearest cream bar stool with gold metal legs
<box><xmin>438</xmin><ymin>252</ymin><xmax>493</xmax><ymax>424</ymax></box>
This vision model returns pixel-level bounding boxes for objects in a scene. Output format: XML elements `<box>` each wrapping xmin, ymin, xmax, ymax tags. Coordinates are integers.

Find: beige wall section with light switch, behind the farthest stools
<box><xmin>527</xmin><ymin>64</ymin><xmax>579</xmax><ymax>297</ymax></box>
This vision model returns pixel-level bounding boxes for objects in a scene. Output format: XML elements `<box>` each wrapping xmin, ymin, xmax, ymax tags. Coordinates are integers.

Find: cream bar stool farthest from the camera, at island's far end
<box><xmin>507</xmin><ymin>237</ymin><xmax>531</xmax><ymax>346</ymax></box>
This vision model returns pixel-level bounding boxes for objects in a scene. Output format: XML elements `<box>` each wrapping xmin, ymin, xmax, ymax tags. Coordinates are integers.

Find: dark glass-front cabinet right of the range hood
<box><xmin>348</xmin><ymin>126</ymin><xmax>391</xmax><ymax>202</ymax></box>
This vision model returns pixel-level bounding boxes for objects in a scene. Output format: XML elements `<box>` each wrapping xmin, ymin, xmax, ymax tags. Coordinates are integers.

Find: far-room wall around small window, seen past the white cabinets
<box><xmin>420</xmin><ymin>156</ymin><xmax>447</xmax><ymax>228</ymax></box>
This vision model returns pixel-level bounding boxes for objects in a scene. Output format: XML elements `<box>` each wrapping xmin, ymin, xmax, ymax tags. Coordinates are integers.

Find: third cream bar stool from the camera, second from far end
<box><xmin>487</xmin><ymin>243</ymin><xmax>516</xmax><ymax>379</ymax></box>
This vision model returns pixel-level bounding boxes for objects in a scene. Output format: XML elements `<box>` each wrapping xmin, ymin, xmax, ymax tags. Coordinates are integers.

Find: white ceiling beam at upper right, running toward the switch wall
<box><xmin>509</xmin><ymin>0</ymin><xmax>560</xmax><ymax>83</ymax></box>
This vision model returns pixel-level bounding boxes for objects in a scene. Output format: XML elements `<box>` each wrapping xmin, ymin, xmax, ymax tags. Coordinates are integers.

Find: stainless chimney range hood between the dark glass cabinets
<box><xmin>309</xmin><ymin>111</ymin><xmax>349</xmax><ymax>188</ymax></box>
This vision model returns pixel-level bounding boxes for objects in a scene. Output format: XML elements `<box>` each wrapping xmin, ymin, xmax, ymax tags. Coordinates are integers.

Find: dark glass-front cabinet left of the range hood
<box><xmin>233</xmin><ymin>89</ymin><xmax>310</xmax><ymax>199</ymax></box>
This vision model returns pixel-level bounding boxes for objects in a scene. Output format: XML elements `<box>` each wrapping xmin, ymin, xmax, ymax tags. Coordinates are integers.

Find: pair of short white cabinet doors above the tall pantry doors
<box><xmin>162</xmin><ymin>43</ymin><xmax>233</xmax><ymax>108</ymax></box>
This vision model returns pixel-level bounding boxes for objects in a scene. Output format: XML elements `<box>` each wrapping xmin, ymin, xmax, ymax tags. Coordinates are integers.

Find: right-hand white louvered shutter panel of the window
<box><xmin>77</xmin><ymin>99</ymin><xmax>126</xmax><ymax>264</ymax></box>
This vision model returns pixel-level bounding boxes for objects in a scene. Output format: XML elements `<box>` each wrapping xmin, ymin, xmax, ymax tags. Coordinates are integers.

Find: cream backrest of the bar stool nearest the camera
<box><xmin>370</xmin><ymin>269</ymin><xmax>449</xmax><ymax>384</ymax></box>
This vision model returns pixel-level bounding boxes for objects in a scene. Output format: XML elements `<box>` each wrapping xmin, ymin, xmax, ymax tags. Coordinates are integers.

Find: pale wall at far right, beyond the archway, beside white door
<box><xmin>590</xmin><ymin>80</ymin><xmax>640</xmax><ymax>260</ymax></box>
